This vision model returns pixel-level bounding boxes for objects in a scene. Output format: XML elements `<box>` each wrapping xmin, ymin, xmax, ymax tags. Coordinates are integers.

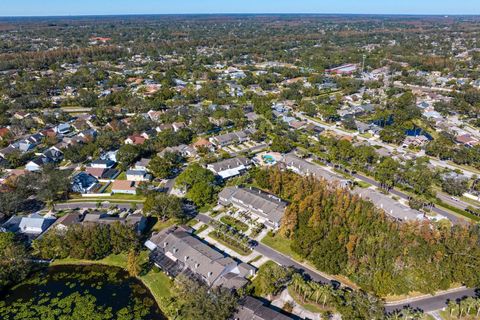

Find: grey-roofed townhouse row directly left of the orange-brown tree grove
<box><xmin>218</xmin><ymin>187</ymin><xmax>288</xmax><ymax>229</ymax></box>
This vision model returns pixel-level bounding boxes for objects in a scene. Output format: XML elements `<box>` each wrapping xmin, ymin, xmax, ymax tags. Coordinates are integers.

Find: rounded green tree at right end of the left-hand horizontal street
<box><xmin>143</xmin><ymin>193</ymin><xmax>185</xmax><ymax>220</ymax></box>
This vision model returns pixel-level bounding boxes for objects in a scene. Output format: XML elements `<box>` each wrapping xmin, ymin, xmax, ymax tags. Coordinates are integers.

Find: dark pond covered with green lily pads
<box><xmin>0</xmin><ymin>265</ymin><xmax>166</xmax><ymax>320</ymax></box>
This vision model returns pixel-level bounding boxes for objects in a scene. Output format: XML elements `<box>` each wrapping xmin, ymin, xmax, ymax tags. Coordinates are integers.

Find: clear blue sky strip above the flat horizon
<box><xmin>0</xmin><ymin>0</ymin><xmax>480</xmax><ymax>16</ymax></box>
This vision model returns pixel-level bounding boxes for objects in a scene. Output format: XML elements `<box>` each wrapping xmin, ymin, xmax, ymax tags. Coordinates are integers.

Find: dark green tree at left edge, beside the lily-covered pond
<box><xmin>0</xmin><ymin>232</ymin><xmax>31</xmax><ymax>290</ymax></box>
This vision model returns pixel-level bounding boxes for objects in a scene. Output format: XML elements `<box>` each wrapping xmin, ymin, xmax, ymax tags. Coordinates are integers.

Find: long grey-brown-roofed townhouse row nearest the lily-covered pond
<box><xmin>145</xmin><ymin>227</ymin><xmax>256</xmax><ymax>289</ymax></box>
